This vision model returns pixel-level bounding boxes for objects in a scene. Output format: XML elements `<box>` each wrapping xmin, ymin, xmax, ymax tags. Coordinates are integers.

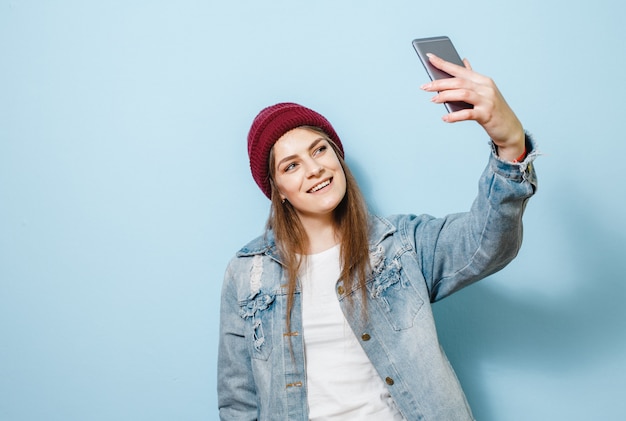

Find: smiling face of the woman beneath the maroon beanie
<box><xmin>273</xmin><ymin>128</ymin><xmax>346</xmax><ymax>219</ymax></box>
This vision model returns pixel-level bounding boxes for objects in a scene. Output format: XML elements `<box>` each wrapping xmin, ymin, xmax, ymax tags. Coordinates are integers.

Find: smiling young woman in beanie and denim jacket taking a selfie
<box><xmin>218</xmin><ymin>56</ymin><xmax>536</xmax><ymax>421</ymax></box>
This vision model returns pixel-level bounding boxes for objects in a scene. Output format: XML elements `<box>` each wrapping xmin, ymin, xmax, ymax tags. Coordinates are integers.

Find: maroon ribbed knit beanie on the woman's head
<box><xmin>248</xmin><ymin>102</ymin><xmax>344</xmax><ymax>198</ymax></box>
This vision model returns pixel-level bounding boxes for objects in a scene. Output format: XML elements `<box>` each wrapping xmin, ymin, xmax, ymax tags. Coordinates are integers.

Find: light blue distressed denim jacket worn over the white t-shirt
<box><xmin>218</xmin><ymin>137</ymin><xmax>536</xmax><ymax>421</ymax></box>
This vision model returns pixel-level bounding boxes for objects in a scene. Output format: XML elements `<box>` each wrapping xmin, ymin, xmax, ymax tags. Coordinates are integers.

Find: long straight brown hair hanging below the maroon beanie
<box><xmin>267</xmin><ymin>126</ymin><xmax>369</xmax><ymax>331</ymax></box>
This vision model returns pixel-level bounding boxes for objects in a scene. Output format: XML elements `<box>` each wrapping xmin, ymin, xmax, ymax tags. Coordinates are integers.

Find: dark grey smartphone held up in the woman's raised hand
<box><xmin>413</xmin><ymin>36</ymin><xmax>474</xmax><ymax>113</ymax></box>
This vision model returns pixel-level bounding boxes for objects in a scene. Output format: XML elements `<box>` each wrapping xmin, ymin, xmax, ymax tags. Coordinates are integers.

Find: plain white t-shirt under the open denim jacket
<box><xmin>301</xmin><ymin>245</ymin><xmax>404</xmax><ymax>421</ymax></box>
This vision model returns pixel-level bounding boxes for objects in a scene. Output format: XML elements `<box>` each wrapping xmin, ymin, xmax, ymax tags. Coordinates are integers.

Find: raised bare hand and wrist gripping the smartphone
<box><xmin>421</xmin><ymin>54</ymin><xmax>525</xmax><ymax>161</ymax></box>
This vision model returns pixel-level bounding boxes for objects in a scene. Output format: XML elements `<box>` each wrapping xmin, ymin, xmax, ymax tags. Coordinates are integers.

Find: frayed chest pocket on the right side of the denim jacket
<box><xmin>368</xmin><ymin>258</ymin><xmax>424</xmax><ymax>330</ymax></box>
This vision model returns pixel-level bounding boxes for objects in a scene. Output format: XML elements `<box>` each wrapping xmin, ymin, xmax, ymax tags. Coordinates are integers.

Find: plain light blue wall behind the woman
<box><xmin>0</xmin><ymin>0</ymin><xmax>626</xmax><ymax>421</ymax></box>
